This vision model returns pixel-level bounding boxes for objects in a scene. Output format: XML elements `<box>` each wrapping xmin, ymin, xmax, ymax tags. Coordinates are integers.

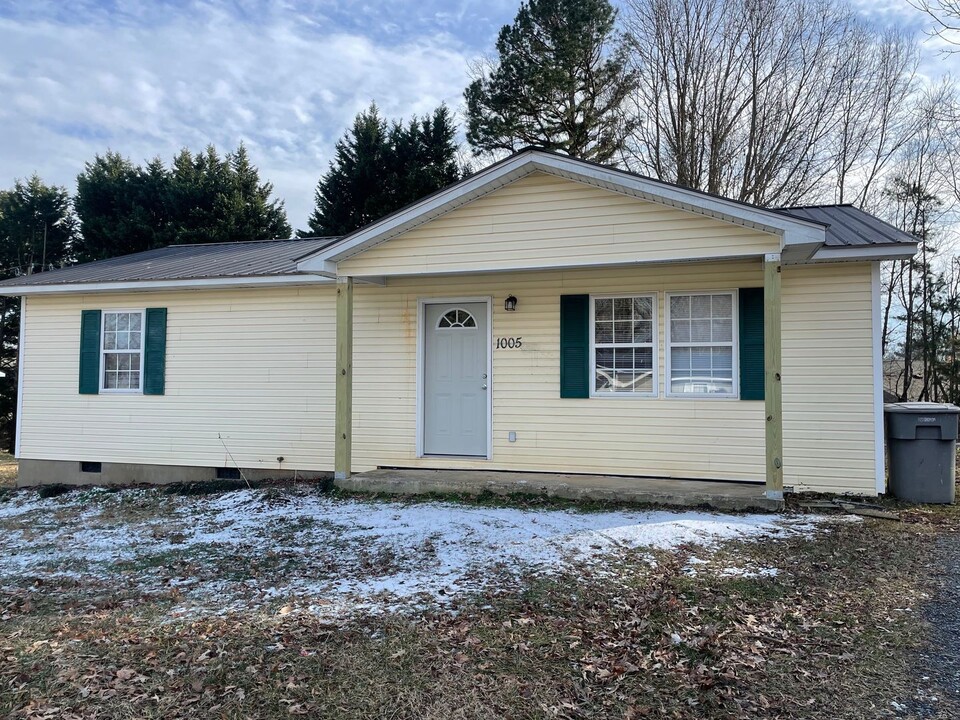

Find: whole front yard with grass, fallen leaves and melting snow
<box><xmin>0</xmin><ymin>486</ymin><xmax>960</xmax><ymax>720</ymax></box>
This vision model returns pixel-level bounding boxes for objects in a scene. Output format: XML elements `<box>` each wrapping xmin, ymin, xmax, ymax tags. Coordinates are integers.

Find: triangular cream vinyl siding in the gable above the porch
<box><xmin>338</xmin><ymin>173</ymin><xmax>780</xmax><ymax>276</ymax></box>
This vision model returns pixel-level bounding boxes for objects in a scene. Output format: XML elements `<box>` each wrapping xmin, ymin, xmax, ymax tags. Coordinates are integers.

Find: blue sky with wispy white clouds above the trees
<box><xmin>0</xmin><ymin>0</ymin><xmax>960</xmax><ymax>227</ymax></box>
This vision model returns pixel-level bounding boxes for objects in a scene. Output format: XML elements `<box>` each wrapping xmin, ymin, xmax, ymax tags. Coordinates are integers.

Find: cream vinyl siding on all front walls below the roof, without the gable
<box><xmin>21</xmin><ymin>260</ymin><xmax>874</xmax><ymax>494</ymax></box>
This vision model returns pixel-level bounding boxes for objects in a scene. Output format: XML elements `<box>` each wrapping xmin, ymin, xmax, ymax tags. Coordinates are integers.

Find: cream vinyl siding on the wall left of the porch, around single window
<box><xmin>20</xmin><ymin>287</ymin><xmax>336</xmax><ymax>470</ymax></box>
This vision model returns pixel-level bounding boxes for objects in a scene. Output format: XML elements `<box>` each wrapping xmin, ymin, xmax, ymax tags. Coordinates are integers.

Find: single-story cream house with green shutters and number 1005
<box><xmin>0</xmin><ymin>150</ymin><xmax>916</xmax><ymax>497</ymax></box>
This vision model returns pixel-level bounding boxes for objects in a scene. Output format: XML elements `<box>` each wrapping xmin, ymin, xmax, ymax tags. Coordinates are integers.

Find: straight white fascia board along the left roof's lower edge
<box><xmin>0</xmin><ymin>274</ymin><xmax>336</xmax><ymax>297</ymax></box>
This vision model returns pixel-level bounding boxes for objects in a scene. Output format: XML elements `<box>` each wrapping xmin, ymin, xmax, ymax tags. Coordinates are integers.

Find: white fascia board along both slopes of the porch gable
<box><xmin>297</xmin><ymin>150</ymin><xmax>826</xmax><ymax>272</ymax></box>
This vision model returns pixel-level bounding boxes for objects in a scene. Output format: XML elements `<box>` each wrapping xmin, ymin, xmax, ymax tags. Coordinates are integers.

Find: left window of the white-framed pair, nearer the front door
<box><xmin>591</xmin><ymin>295</ymin><xmax>657</xmax><ymax>396</ymax></box>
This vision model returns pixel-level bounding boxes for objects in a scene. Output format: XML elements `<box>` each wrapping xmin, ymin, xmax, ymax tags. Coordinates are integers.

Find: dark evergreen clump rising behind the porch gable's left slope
<box><xmin>300</xmin><ymin>104</ymin><xmax>463</xmax><ymax>236</ymax></box>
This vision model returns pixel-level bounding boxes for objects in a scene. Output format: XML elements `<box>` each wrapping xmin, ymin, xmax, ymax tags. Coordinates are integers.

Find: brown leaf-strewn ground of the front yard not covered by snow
<box><xmin>0</xmin><ymin>484</ymin><xmax>956</xmax><ymax>720</ymax></box>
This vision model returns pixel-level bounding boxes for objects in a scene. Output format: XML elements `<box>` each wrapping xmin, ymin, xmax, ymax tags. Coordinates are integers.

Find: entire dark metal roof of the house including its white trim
<box><xmin>0</xmin><ymin>148</ymin><xmax>917</xmax><ymax>295</ymax></box>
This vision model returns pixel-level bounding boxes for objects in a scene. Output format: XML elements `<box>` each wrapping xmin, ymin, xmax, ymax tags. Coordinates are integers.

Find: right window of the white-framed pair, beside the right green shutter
<box><xmin>667</xmin><ymin>292</ymin><xmax>737</xmax><ymax>396</ymax></box>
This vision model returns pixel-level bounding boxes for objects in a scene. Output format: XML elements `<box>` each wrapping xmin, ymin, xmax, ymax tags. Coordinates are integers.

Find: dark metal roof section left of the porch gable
<box><xmin>0</xmin><ymin>237</ymin><xmax>337</xmax><ymax>287</ymax></box>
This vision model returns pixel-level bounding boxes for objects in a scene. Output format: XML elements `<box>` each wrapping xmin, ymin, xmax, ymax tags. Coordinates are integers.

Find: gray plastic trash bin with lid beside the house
<box><xmin>885</xmin><ymin>402</ymin><xmax>960</xmax><ymax>503</ymax></box>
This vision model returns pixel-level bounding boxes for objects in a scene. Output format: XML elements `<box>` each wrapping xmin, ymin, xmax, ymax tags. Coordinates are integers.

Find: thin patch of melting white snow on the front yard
<box><xmin>0</xmin><ymin>486</ymin><xmax>823</xmax><ymax>617</ymax></box>
